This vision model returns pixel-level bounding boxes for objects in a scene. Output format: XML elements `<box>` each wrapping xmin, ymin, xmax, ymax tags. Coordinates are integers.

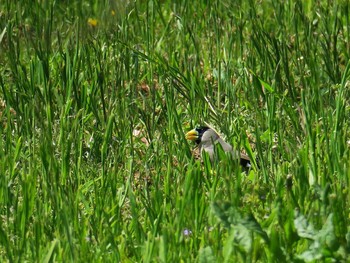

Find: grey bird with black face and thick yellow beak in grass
<box><xmin>185</xmin><ymin>126</ymin><xmax>252</xmax><ymax>169</ymax></box>
